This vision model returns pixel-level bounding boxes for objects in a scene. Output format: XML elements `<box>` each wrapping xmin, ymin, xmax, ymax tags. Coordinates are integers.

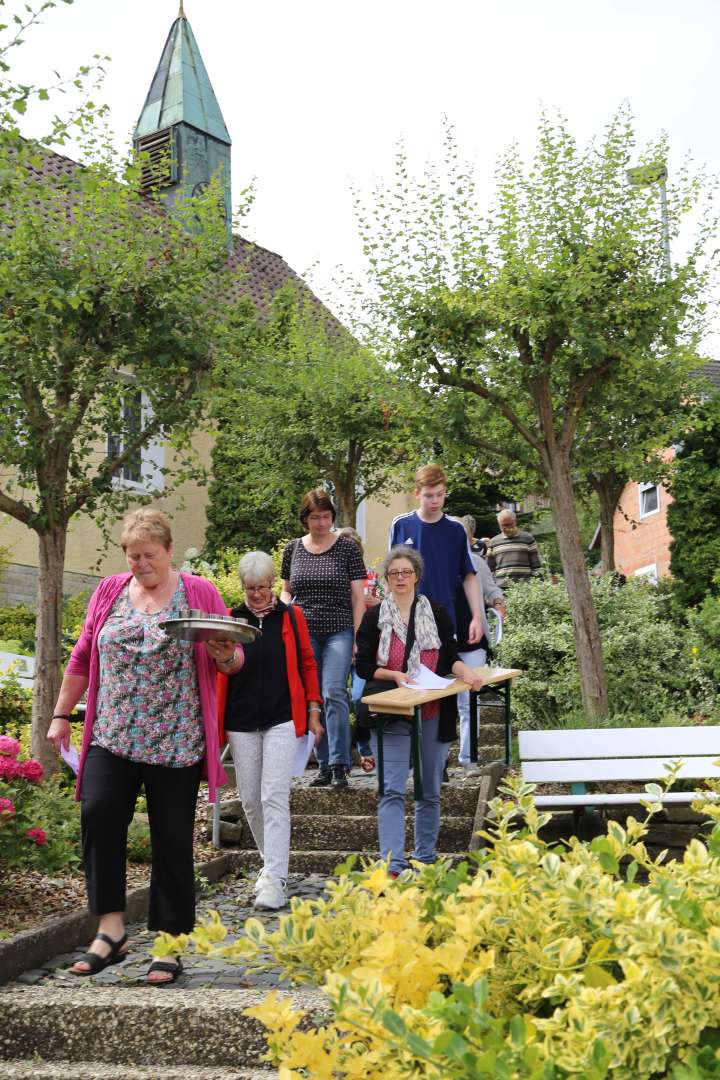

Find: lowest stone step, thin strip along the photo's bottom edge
<box><xmin>2</xmin><ymin>1059</ymin><xmax>277</xmax><ymax>1080</ymax></box>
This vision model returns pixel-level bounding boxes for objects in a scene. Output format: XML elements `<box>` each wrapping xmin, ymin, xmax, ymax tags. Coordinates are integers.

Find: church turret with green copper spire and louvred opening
<box><xmin>133</xmin><ymin>2</ymin><xmax>232</xmax><ymax>238</ymax></box>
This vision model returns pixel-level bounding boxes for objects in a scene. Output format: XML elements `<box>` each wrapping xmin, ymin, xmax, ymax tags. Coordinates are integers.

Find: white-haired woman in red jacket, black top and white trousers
<box><xmin>213</xmin><ymin>551</ymin><xmax>323</xmax><ymax>910</ymax></box>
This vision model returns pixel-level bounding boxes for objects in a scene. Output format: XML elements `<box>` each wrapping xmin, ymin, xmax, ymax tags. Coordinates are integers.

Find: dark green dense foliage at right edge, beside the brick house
<box><xmin>667</xmin><ymin>396</ymin><xmax>720</xmax><ymax>609</ymax></box>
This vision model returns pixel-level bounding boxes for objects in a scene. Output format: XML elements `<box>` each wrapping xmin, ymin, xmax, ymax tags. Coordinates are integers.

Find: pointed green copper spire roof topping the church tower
<box><xmin>134</xmin><ymin>11</ymin><xmax>231</xmax><ymax>146</ymax></box>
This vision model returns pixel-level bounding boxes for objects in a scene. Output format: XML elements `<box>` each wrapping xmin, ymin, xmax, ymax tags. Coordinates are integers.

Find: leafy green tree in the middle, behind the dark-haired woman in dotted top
<box><xmin>208</xmin><ymin>284</ymin><xmax>412</xmax><ymax>549</ymax></box>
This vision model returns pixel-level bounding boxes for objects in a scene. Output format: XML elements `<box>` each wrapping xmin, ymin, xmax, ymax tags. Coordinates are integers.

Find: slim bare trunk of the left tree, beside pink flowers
<box><xmin>32</xmin><ymin>524</ymin><xmax>67</xmax><ymax>773</ymax></box>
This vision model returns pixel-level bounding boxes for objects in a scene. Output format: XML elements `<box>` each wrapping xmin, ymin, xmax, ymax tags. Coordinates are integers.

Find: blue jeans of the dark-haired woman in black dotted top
<box><xmin>310</xmin><ymin>630</ymin><xmax>355</xmax><ymax>769</ymax></box>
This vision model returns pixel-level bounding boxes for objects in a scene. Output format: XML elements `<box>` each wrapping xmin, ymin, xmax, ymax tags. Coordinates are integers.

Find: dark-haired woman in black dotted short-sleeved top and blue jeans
<box><xmin>280</xmin><ymin>488</ymin><xmax>367</xmax><ymax>788</ymax></box>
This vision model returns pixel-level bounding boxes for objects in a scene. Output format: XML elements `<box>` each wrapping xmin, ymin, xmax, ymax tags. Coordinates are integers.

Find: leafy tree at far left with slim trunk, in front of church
<box><xmin>0</xmin><ymin>4</ymin><xmax>253</xmax><ymax>768</ymax></box>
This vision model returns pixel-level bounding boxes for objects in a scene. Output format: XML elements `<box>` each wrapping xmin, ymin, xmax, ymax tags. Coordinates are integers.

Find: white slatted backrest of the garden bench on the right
<box><xmin>519</xmin><ymin>727</ymin><xmax>720</xmax><ymax>783</ymax></box>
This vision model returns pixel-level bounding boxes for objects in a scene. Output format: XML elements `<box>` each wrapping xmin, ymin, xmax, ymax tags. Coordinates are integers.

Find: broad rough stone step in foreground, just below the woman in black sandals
<box><xmin>0</xmin><ymin>984</ymin><xmax>327</xmax><ymax>1080</ymax></box>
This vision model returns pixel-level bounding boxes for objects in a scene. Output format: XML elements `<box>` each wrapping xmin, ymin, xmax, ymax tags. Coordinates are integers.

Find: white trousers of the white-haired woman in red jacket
<box><xmin>228</xmin><ymin>720</ymin><xmax>297</xmax><ymax>879</ymax></box>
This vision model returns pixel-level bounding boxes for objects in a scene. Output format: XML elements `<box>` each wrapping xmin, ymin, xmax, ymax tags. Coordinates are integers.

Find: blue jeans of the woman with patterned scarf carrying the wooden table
<box><xmin>371</xmin><ymin>717</ymin><xmax>449</xmax><ymax>874</ymax></box>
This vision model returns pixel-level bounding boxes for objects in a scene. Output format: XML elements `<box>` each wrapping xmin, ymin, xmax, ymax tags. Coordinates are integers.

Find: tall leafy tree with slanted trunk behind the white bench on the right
<box><xmin>361</xmin><ymin>110</ymin><xmax>710</xmax><ymax>717</ymax></box>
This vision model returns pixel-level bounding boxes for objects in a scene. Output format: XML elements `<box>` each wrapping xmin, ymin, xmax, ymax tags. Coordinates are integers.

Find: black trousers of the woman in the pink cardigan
<box><xmin>81</xmin><ymin>746</ymin><xmax>201</xmax><ymax>934</ymax></box>
